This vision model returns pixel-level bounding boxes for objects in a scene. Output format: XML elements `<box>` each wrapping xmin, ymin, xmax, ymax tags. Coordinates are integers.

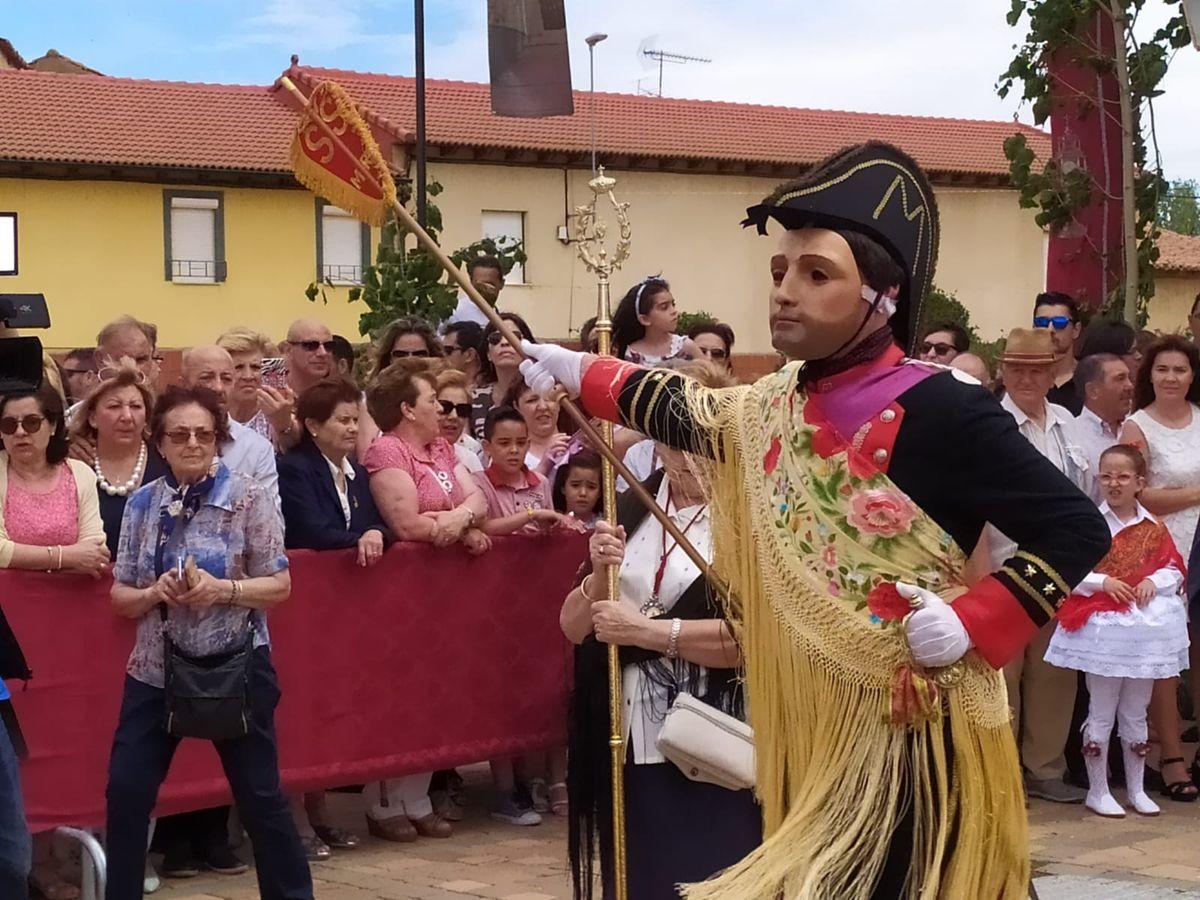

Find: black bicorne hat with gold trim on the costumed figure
<box><xmin>742</xmin><ymin>140</ymin><xmax>938</xmax><ymax>350</ymax></box>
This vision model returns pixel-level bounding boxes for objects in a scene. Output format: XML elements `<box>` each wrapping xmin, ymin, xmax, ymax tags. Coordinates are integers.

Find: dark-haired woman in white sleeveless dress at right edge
<box><xmin>1121</xmin><ymin>335</ymin><xmax>1200</xmax><ymax>803</ymax></box>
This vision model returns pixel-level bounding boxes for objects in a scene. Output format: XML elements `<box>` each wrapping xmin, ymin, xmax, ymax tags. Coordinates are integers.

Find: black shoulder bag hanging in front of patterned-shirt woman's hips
<box><xmin>158</xmin><ymin>604</ymin><xmax>254</xmax><ymax>740</ymax></box>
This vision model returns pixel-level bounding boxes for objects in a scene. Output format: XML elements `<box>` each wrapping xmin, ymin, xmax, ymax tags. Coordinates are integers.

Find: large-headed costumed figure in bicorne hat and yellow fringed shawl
<box><xmin>522</xmin><ymin>143</ymin><xmax>1109</xmax><ymax>900</ymax></box>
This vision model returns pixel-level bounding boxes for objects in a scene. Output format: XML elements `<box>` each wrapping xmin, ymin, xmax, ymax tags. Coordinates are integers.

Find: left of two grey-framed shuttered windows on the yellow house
<box><xmin>163</xmin><ymin>191</ymin><xmax>226</xmax><ymax>284</ymax></box>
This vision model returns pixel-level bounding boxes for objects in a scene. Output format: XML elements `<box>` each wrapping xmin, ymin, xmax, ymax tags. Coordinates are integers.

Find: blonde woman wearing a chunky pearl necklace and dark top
<box><xmin>72</xmin><ymin>367</ymin><xmax>167</xmax><ymax>559</ymax></box>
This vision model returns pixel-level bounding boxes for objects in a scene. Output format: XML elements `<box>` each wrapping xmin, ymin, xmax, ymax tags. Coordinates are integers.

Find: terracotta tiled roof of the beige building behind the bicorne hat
<box><xmin>289</xmin><ymin>66</ymin><xmax>1050</xmax><ymax>175</ymax></box>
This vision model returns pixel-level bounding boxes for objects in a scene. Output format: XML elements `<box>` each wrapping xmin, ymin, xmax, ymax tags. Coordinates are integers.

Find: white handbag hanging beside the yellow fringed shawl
<box><xmin>655</xmin><ymin>694</ymin><xmax>755</xmax><ymax>791</ymax></box>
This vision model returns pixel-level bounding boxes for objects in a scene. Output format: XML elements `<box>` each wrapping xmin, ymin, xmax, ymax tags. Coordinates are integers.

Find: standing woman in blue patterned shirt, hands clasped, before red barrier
<box><xmin>106</xmin><ymin>388</ymin><xmax>313</xmax><ymax>900</ymax></box>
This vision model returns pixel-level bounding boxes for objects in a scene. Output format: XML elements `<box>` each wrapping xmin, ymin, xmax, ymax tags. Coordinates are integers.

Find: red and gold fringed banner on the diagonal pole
<box><xmin>292</xmin><ymin>82</ymin><xmax>396</xmax><ymax>226</ymax></box>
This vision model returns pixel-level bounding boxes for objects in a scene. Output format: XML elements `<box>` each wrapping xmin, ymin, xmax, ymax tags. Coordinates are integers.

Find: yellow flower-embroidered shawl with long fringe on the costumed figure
<box><xmin>684</xmin><ymin>366</ymin><xmax>1030</xmax><ymax>900</ymax></box>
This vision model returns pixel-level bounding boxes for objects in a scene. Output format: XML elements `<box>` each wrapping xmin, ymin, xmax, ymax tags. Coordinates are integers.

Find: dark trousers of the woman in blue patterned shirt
<box><xmin>104</xmin><ymin>647</ymin><xmax>313</xmax><ymax>900</ymax></box>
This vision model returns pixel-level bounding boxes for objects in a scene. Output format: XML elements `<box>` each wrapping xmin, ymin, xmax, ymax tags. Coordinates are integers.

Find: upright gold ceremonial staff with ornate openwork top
<box><xmin>575</xmin><ymin>166</ymin><xmax>633</xmax><ymax>900</ymax></box>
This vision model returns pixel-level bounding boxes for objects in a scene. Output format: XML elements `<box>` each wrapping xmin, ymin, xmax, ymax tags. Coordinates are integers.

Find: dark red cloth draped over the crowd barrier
<box><xmin>0</xmin><ymin>534</ymin><xmax>587</xmax><ymax>832</ymax></box>
